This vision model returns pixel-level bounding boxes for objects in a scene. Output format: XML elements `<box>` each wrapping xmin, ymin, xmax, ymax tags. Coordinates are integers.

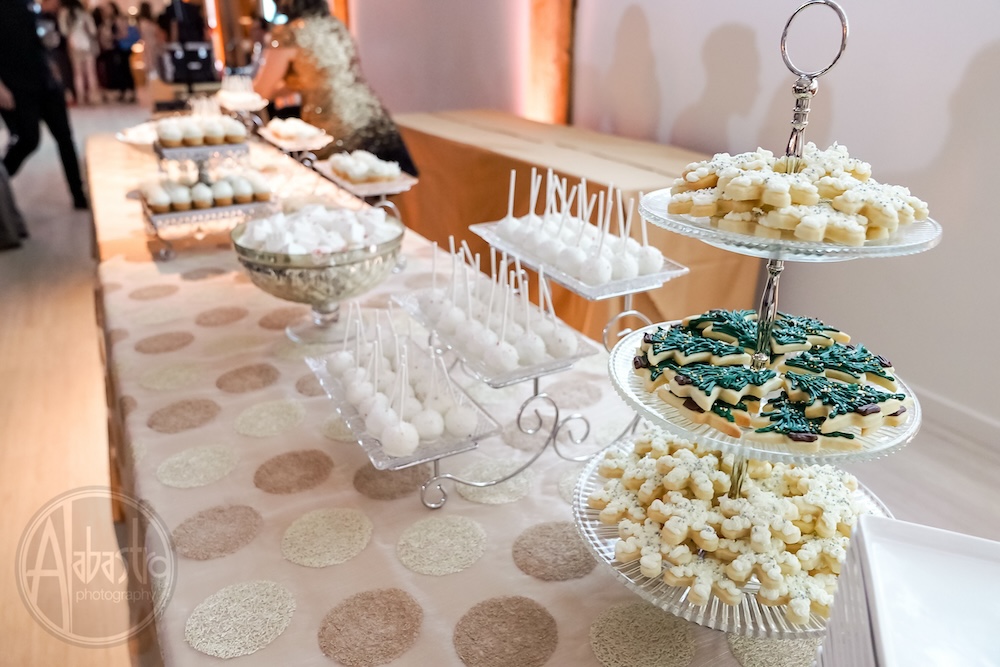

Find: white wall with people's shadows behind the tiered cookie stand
<box><xmin>574</xmin><ymin>0</ymin><xmax>1000</xmax><ymax>444</ymax></box>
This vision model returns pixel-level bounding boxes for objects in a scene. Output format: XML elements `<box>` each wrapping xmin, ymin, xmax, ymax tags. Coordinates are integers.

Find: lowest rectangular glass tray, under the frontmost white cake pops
<box><xmin>298</xmin><ymin>344</ymin><xmax>500</xmax><ymax>470</ymax></box>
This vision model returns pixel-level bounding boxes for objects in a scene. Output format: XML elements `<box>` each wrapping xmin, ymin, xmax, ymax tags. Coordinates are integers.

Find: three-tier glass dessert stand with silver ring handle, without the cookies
<box><xmin>573</xmin><ymin>0</ymin><xmax>941</xmax><ymax>638</ymax></box>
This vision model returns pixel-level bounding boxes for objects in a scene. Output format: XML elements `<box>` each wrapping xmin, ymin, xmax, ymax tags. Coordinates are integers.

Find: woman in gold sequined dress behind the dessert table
<box><xmin>254</xmin><ymin>0</ymin><xmax>417</xmax><ymax>175</ymax></box>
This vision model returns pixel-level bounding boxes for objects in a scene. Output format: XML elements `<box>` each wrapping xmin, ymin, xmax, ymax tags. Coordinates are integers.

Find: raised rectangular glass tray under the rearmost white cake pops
<box><xmin>469</xmin><ymin>222</ymin><xmax>690</xmax><ymax>301</ymax></box>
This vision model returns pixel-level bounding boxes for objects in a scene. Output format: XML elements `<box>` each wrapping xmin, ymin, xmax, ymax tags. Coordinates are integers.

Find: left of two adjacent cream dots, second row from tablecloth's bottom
<box><xmin>281</xmin><ymin>508</ymin><xmax>373</xmax><ymax>567</ymax></box>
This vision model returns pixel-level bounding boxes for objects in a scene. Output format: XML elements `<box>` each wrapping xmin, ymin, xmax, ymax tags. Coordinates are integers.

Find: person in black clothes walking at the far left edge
<box><xmin>0</xmin><ymin>0</ymin><xmax>87</xmax><ymax>209</ymax></box>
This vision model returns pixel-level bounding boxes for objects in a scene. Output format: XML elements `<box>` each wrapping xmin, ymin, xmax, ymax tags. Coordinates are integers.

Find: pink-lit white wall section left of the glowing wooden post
<box><xmin>350</xmin><ymin>0</ymin><xmax>531</xmax><ymax>113</ymax></box>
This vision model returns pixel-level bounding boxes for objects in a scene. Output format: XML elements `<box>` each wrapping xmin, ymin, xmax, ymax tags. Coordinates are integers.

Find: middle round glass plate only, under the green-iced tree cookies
<box><xmin>608</xmin><ymin>322</ymin><xmax>921</xmax><ymax>465</ymax></box>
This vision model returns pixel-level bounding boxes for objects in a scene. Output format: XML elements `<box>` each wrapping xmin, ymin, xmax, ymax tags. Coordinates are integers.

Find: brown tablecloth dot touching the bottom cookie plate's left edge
<box><xmin>512</xmin><ymin>521</ymin><xmax>597</xmax><ymax>581</ymax></box>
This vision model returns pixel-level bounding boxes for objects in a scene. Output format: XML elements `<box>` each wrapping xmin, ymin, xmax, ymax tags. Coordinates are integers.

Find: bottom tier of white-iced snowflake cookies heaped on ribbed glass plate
<box><xmin>577</xmin><ymin>429</ymin><xmax>887</xmax><ymax>635</ymax></box>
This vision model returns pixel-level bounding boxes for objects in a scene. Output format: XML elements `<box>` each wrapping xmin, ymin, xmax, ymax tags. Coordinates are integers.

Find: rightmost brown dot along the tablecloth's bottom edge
<box><xmin>454</xmin><ymin>595</ymin><xmax>559</xmax><ymax>667</ymax></box>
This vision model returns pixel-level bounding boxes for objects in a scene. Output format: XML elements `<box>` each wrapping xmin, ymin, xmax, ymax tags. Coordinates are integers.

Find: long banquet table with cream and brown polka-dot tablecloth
<box><xmin>87</xmin><ymin>136</ymin><xmax>811</xmax><ymax>667</ymax></box>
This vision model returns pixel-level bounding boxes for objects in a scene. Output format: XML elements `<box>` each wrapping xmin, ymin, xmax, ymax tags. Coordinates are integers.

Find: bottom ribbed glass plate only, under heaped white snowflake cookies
<box><xmin>573</xmin><ymin>441</ymin><xmax>892</xmax><ymax>639</ymax></box>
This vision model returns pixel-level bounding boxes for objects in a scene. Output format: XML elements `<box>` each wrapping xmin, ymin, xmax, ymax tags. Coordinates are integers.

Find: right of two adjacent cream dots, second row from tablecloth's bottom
<box><xmin>396</xmin><ymin>516</ymin><xmax>486</xmax><ymax>577</ymax></box>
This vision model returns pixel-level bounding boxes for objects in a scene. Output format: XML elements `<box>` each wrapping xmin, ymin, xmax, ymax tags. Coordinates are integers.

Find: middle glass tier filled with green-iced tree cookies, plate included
<box><xmin>609</xmin><ymin>310</ymin><xmax>920</xmax><ymax>462</ymax></box>
